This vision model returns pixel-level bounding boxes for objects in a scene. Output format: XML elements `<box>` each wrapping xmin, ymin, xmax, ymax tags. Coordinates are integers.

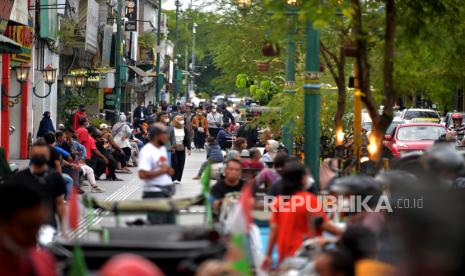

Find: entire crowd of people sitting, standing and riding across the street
<box><xmin>0</xmin><ymin>102</ymin><xmax>465</xmax><ymax>276</ymax></box>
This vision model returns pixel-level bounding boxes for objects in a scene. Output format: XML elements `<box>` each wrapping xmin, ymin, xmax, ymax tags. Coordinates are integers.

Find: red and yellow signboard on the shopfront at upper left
<box><xmin>5</xmin><ymin>25</ymin><xmax>34</xmax><ymax>63</ymax></box>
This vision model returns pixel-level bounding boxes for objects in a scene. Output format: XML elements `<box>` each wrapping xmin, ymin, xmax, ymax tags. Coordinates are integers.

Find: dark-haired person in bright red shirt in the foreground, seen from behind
<box><xmin>263</xmin><ymin>161</ymin><xmax>342</xmax><ymax>269</ymax></box>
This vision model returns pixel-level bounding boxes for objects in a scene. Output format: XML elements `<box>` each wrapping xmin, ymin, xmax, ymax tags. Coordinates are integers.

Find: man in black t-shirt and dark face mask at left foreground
<box><xmin>10</xmin><ymin>139</ymin><xmax>66</xmax><ymax>232</ymax></box>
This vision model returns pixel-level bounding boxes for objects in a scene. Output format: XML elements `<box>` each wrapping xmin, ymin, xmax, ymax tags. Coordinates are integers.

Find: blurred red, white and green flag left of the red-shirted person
<box><xmin>226</xmin><ymin>182</ymin><xmax>254</xmax><ymax>276</ymax></box>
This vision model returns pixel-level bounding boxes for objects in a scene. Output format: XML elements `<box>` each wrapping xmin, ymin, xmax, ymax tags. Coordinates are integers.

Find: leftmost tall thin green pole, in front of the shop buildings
<box><xmin>115</xmin><ymin>0</ymin><xmax>123</xmax><ymax>115</ymax></box>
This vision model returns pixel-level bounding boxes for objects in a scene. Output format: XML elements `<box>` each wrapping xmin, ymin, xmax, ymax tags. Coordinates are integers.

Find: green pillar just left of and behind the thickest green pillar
<box><xmin>282</xmin><ymin>15</ymin><xmax>296</xmax><ymax>155</ymax></box>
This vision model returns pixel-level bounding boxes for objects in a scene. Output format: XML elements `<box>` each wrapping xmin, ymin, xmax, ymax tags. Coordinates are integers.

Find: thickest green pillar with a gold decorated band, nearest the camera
<box><xmin>304</xmin><ymin>21</ymin><xmax>320</xmax><ymax>188</ymax></box>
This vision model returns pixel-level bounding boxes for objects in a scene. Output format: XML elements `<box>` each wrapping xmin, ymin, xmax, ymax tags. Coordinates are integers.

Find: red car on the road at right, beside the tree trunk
<box><xmin>384</xmin><ymin>123</ymin><xmax>446</xmax><ymax>157</ymax></box>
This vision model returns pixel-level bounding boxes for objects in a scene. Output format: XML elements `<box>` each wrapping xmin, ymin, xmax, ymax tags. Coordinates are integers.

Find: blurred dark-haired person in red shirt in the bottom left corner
<box><xmin>0</xmin><ymin>180</ymin><xmax>57</xmax><ymax>276</ymax></box>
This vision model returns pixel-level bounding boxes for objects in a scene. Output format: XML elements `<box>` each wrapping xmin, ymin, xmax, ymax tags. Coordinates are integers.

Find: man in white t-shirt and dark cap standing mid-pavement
<box><xmin>137</xmin><ymin>123</ymin><xmax>175</xmax><ymax>224</ymax></box>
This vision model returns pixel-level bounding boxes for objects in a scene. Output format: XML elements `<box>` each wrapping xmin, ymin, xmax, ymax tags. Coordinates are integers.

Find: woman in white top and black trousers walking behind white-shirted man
<box><xmin>172</xmin><ymin>115</ymin><xmax>191</xmax><ymax>184</ymax></box>
